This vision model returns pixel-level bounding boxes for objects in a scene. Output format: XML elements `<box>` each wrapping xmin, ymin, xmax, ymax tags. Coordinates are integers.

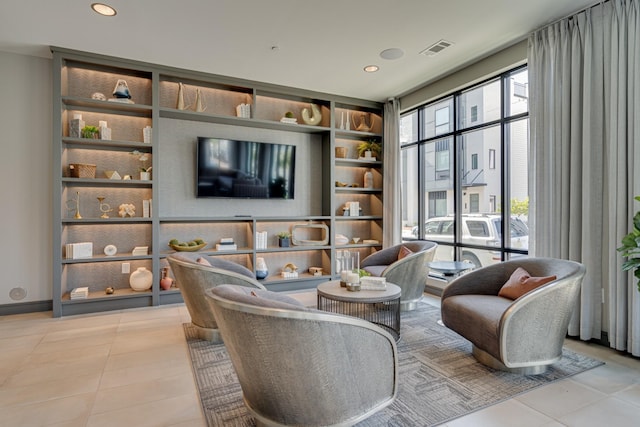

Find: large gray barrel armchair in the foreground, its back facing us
<box><xmin>207</xmin><ymin>285</ymin><xmax>398</xmax><ymax>426</ymax></box>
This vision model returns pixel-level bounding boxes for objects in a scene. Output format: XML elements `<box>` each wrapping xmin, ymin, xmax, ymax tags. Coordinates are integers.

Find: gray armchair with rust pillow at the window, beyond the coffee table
<box><xmin>360</xmin><ymin>240</ymin><xmax>438</xmax><ymax>311</ymax></box>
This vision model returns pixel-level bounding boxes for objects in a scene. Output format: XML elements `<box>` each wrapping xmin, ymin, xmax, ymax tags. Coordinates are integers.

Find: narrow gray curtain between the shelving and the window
<box><xmin>382</xmin><ymin>98</ymin><xmax>402</xmax><ymax>247</ymax></box>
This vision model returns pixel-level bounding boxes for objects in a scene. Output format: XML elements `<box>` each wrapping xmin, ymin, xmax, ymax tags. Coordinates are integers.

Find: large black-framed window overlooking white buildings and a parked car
<box><xmin>400</xmin><ymin>67</ymin><xmax>529</xmax><ymax>266</ymax></box>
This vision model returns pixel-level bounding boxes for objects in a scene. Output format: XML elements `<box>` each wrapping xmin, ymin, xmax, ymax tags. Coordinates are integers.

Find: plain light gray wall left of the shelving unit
<box><xmin>0</xmin><ymin>52</ymin><xmax>53</xmax><ymax>305</ymax></box>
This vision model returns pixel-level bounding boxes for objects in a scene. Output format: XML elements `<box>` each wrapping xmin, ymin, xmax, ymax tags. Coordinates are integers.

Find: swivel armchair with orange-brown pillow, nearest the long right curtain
<box><xmin>441</xmin><ymin>258</ymin><xmax>585</xmax><ymax>375</ymax></box>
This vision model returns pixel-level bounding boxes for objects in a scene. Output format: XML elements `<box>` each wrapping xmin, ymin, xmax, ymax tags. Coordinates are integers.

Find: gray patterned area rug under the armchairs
<box><xmin>184</xmin><ymin>303</ymin><xmax>602</xmax><ymax>427</ymax></box>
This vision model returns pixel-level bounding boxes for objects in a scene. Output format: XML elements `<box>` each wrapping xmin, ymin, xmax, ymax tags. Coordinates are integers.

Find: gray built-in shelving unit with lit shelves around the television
<box><xmin>52</xmin><ymin>48</ymin><xmax>383</xmax><ymax>316</ymax></box>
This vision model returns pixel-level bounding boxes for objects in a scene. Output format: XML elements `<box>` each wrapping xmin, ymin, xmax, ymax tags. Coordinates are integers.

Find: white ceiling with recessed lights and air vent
<box><xmin>0</xmin><ymin>0</ymin><xmax>595</xmax><ymax>101</ymax></box>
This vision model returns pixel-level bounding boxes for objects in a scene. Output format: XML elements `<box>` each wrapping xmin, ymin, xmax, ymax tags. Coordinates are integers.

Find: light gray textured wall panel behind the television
<box><xmin>158</xmin><ymin>118</ymin><xmax>322</xmax><ymax>218</ymax></box>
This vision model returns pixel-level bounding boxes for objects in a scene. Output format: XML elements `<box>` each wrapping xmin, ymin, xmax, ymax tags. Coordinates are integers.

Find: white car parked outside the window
<box><xmin>413</xmin><ymin>214</ymin><xmax>529</xmax><ymax>268</ymax></box>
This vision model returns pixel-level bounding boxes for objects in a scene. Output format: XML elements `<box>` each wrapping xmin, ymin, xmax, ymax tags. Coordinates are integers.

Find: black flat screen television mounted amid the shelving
<box><xmin>196</xmin><ymin>137</ymin><xmax>296</xmax><ymax>199</ymax></box>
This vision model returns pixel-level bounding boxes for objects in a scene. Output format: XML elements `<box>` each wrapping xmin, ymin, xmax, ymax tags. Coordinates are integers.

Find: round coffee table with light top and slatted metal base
<box><xmin>318</xmin><ymin>280</ymin><xmax>401</xmax><ymax>341</ymax></box>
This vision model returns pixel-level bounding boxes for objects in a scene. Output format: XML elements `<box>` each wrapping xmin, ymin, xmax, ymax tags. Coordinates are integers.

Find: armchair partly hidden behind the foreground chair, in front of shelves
<box><xmin>167</xmin><ymin>252</ymin><xmax>265</xmax><ymax>342</ymax></box>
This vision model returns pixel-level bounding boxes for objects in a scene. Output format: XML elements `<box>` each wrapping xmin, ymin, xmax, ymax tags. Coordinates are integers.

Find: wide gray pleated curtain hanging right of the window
<box><xmin>528</xmin><ymin>0</ymin><xmax>640</xmax><ymax>356</ymax></box>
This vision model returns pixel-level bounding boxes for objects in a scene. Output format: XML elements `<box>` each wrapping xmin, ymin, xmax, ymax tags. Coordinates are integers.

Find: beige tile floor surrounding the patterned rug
<box><xmin>0</xmin><ymin>293</ymin><xmax>640</xmax><ymax>427</ymax></box>
